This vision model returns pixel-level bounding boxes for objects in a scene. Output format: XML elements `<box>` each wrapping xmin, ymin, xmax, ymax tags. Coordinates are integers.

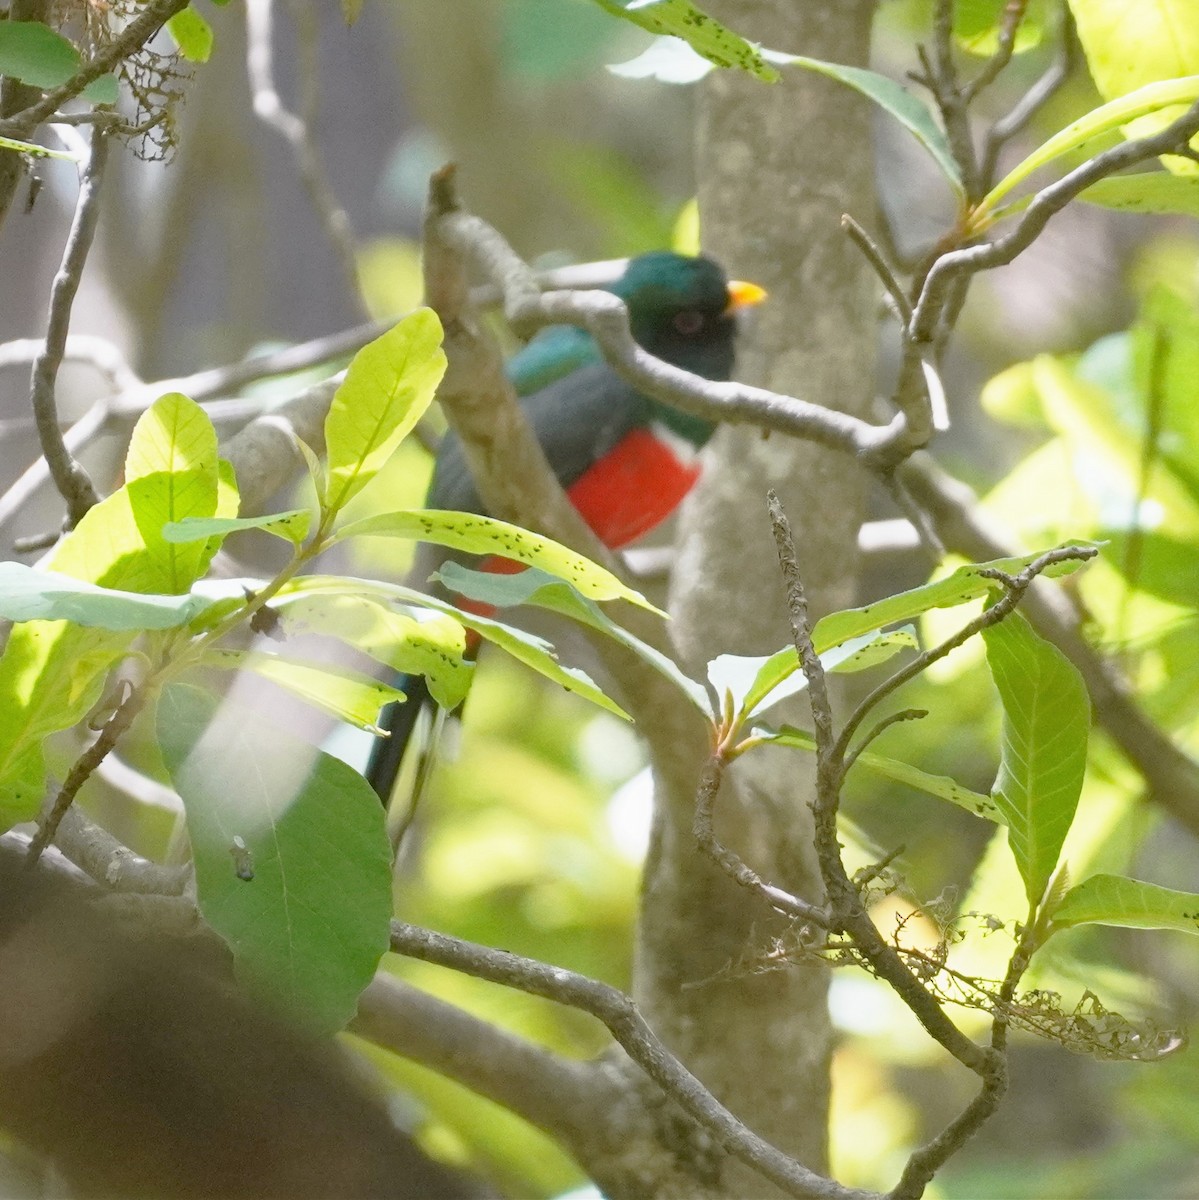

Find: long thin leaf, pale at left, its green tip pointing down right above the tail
<box><xmin>274</xmin><ymin>575</ymin><xmax>631</xmax><ymax>721</ymax></box>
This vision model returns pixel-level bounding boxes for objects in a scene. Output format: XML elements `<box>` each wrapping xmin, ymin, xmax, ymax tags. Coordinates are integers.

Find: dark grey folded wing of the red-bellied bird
<box><xmin>427</xmin><ymin>362</ymin><xmax>649</xmax><ymax>512</ymax></box>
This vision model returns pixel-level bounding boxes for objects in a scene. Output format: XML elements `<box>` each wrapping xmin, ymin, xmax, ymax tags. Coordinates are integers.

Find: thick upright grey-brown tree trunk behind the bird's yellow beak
<box><xmin>636</xmin><ymin>0</ymin><xmax>876</xmax><ymax>1196</ymax></box>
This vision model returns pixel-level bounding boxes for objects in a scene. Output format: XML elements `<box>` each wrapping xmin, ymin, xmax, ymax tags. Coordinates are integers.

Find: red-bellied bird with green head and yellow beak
<box><xmin>366</xmin><ymin>251</ymin><xmax>766</xmax><ymax>805</ymax></box>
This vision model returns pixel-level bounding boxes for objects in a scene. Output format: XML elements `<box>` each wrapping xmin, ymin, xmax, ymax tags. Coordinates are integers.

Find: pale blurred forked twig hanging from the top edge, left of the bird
<box><xmin>246</xmin><ymin>0</ymin><xmax>366</xmax><ymax>314</ymax></box>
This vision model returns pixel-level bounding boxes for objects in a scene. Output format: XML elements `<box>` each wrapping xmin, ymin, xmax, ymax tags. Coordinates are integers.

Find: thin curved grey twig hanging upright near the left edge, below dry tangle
<box><xmin>30</xmin><ymin>126</ymin><xmax>108</xmax><ymax>526</ymax></box>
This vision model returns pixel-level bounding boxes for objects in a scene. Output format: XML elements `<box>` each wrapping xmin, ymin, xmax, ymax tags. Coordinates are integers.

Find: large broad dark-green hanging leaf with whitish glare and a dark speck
<box><xmin>157</xmin><ymin>684</ymin><xmax>391</xmax><ymax>1032</ymax></box>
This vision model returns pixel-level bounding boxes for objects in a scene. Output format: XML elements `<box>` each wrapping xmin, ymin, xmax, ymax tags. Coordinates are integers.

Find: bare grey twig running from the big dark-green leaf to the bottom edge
<box><xmin>391</xmin><ymin>920</ymin><xmax>871</xmax><ymax>1200</ymax></box>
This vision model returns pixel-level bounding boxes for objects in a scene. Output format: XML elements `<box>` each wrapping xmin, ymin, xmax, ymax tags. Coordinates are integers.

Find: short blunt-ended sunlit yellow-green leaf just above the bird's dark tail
<box><xmin>282</xmin><ymin>595</ymin><xmax>474</xmax><ymax>708</ymax></box>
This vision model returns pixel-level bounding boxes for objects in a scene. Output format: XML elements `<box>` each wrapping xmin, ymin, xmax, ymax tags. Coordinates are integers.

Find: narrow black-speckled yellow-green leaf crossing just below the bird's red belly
<box><xmin>336</xmin><ymin>509</ymin><xmax>665</xmax><ymax>616</ymax></box>
